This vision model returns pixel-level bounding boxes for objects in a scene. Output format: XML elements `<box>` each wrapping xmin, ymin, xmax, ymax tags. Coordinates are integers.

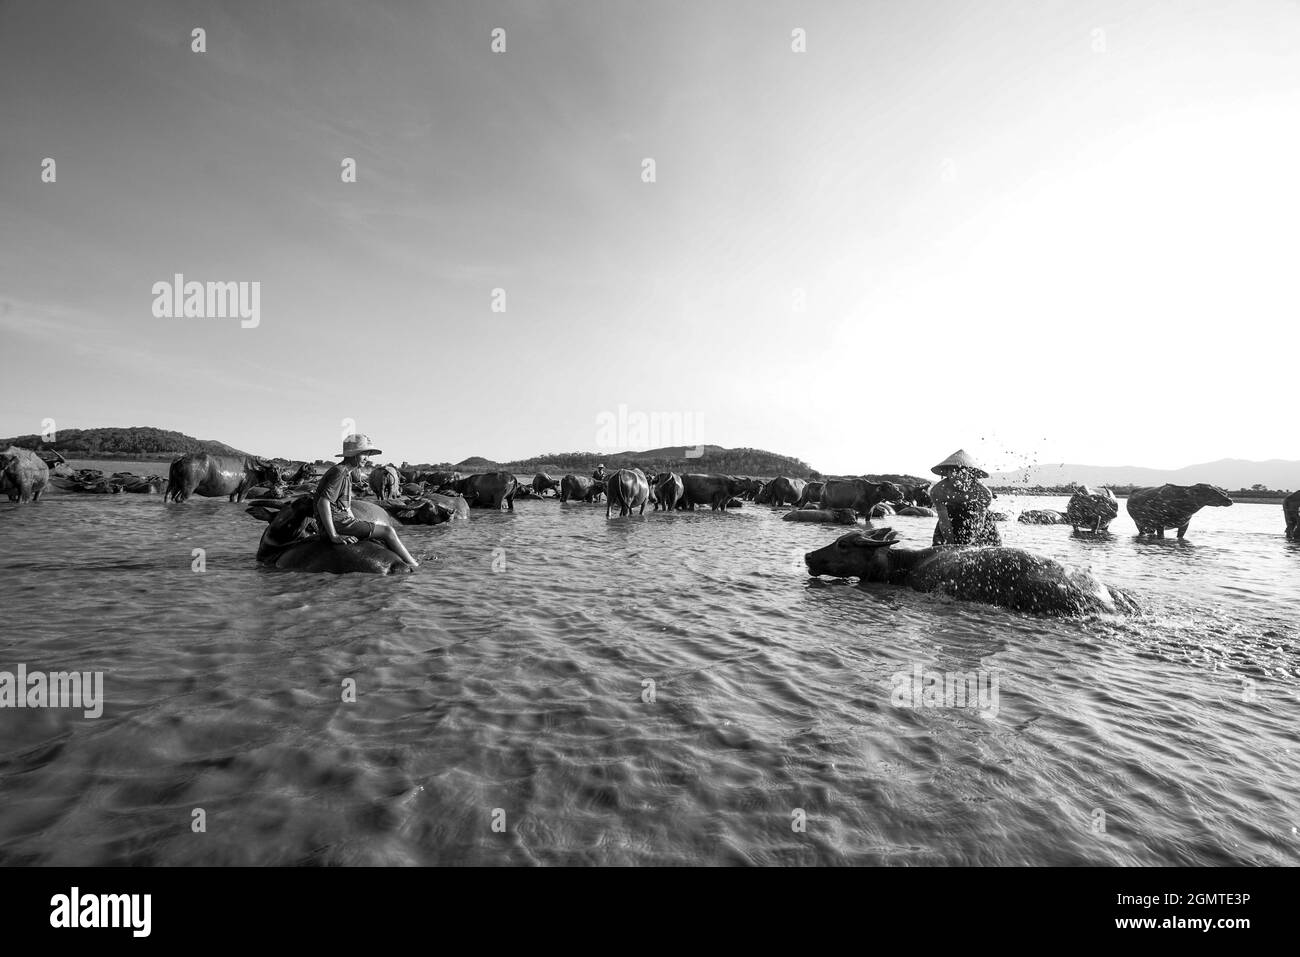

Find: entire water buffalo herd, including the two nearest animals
<box><xmin>0</xmin><ymin>446</ymin><xmax>1300</xmax><ymax>615</ymax></box>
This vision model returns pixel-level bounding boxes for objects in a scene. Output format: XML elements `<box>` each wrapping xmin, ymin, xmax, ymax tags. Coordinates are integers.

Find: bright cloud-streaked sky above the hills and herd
<box><xmin>0</xmin><ymin>0</ymin><xmax>1300</xmax><ymax>473</ymax></box>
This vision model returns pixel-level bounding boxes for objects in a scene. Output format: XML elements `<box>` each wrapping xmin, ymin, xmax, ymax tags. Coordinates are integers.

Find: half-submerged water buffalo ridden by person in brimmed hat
<box><xmin>247</xmin><ymin>495</ymin><xmax>411</xmax><ymax>575</ymax></box>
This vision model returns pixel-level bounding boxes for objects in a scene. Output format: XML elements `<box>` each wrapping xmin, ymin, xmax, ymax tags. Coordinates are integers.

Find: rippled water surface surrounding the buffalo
<box><xmin>0</xmin><ymin>495</ymin><xmax>1300</xmax><ymax>865</ymax></box>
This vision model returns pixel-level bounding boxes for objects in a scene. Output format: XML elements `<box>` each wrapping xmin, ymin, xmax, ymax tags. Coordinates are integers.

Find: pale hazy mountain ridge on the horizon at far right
<box><xmin>989</xmin><ymin>459</ymin><xmax>1300</xmax><ymax>490</ymax></box>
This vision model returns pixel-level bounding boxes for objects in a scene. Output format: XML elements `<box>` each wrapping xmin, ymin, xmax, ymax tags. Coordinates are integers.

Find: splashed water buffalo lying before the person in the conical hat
<box><xmin>803</xmin><ymin>528</ymin><xmax>1140</xmax><ymax>616</ymax></box>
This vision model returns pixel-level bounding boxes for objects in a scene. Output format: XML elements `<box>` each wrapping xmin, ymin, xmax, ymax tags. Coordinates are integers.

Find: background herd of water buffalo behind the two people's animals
<box><xmin>0</xmin><ymin>446</ymin><xmax>1300</xmax><ymax>541</ymax></box>
